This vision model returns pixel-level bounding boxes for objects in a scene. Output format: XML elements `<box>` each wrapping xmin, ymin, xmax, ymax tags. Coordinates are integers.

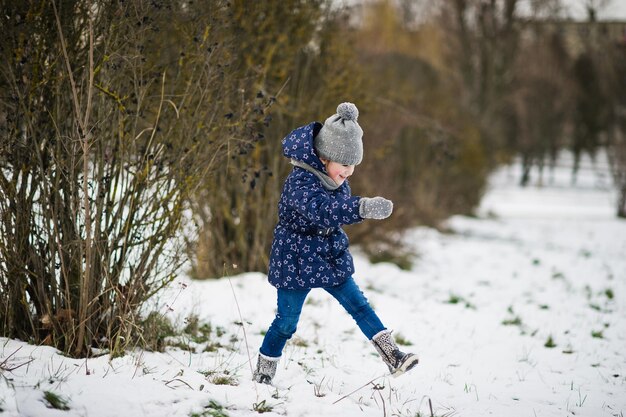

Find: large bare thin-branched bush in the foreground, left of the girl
<box><xmin>0</xmin><ymin>0</ymin><xmax>267</xmax><ymax>356</ymax></box>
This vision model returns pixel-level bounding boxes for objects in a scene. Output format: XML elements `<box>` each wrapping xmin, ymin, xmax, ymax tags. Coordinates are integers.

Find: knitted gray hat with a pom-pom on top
<box><xmin>314</xmin><ymin>103</ymin><xmax>363</xmax><ymax>165</ymax></box>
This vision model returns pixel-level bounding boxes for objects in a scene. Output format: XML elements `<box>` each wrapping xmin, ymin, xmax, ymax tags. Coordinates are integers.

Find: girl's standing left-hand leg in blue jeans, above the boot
<box><xmin>260</xmin><ymin>289</ymin><xmax>309</xmax><ymax>358</ymax></box>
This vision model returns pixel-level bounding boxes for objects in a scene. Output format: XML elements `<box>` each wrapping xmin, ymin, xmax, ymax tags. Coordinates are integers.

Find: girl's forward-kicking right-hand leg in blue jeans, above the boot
<box><xmin>324</xmin><ymin>277</ymin><xmax>385</xmax><ymax>340</ymax></box>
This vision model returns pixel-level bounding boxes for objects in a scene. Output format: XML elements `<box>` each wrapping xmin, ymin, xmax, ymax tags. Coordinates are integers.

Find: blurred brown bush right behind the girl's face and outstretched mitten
<box><xmin>350</xmin><ymin>2</ymin><xmax>489</xmax><ymax>263</ymax></box>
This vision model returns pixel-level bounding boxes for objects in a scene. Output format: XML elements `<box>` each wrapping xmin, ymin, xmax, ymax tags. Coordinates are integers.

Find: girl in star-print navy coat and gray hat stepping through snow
<box><xmin>253</xmin><ymin>103</ymin><xmax>418</xmax><ymax>384</ymax></box>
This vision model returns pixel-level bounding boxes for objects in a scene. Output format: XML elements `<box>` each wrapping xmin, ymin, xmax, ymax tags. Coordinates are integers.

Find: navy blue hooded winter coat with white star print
<box><xmin>268</xmin><ymin>122</ymin><xmax>363</xmax><ymax>289</ymax></box>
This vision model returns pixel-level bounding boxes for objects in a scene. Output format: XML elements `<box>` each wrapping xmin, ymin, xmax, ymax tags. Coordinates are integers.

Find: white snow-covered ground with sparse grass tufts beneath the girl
<box><xmin>0</xmin><ymin>154</ymin><xmax>626</xmax><ymax>417</ymax></box>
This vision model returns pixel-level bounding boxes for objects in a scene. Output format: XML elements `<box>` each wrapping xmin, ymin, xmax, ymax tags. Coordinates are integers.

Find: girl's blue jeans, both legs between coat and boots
<box><xmin>260</xmin><ymin>278</ymin><xmax>385</xmax><ymax>358</ymax></box>
